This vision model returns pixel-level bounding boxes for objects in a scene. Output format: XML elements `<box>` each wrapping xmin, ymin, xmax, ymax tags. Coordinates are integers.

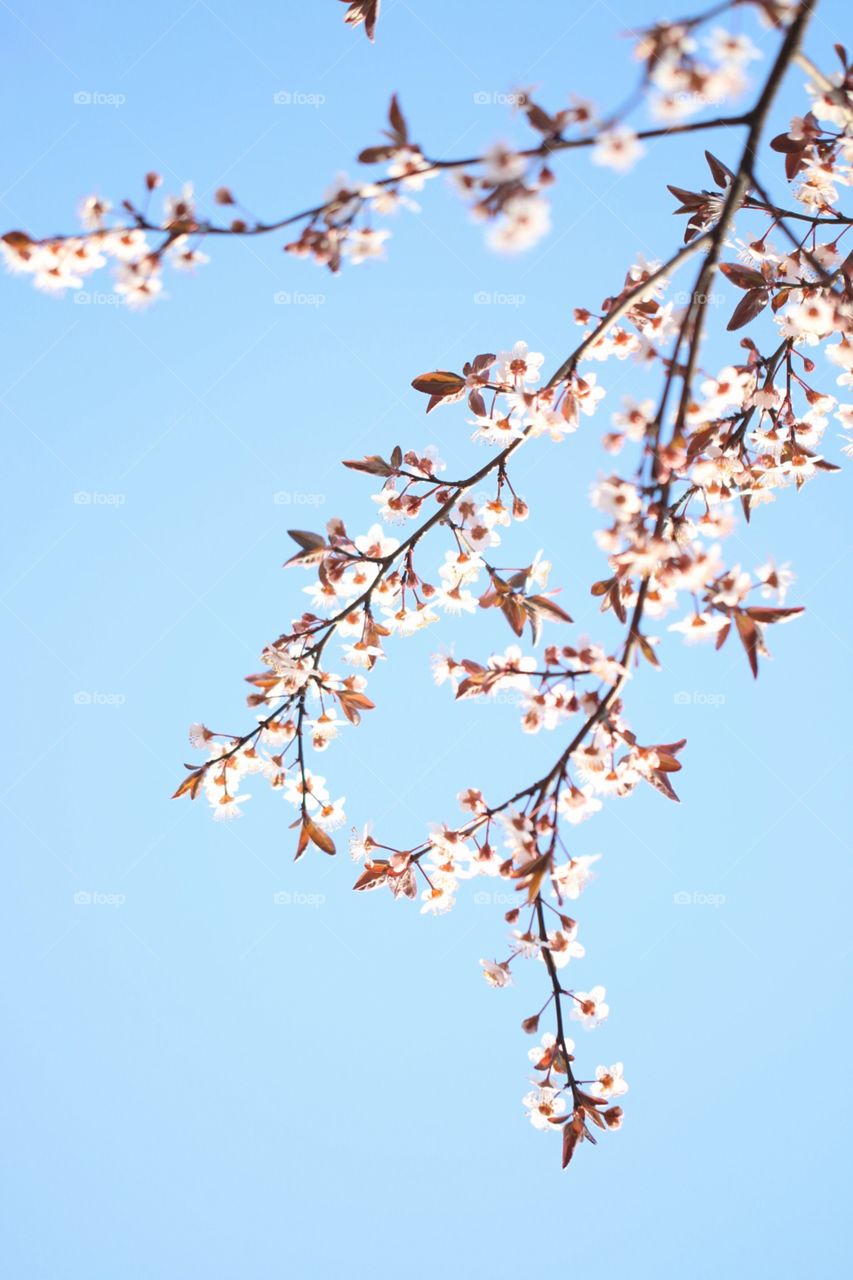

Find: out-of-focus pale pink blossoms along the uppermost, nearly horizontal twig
<box><xmin>0</xmin><ymin>0</ymin><xmax>773</xmax><ymax>299</ymax></box>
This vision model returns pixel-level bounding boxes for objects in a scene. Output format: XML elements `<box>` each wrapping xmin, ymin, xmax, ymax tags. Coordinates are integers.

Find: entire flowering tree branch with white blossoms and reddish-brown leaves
<box><xmin>12</xmin><ymin>0</ymin><xmax>853</xmax><ymax>1166</ymax></box>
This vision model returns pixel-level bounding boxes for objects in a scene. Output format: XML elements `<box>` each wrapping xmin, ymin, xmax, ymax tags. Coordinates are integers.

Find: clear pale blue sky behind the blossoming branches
<box><xmin>0</xmin><ymin>0</ymin><xmax>853</xmax><ymax>1280</ymax></box>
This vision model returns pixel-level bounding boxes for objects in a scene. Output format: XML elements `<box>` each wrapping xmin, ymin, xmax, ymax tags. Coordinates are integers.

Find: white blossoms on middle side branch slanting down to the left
<box><xmin>178</xmin><ymin>342</ymin><xmax>578</xmax><ymax>834</ymax></box>
